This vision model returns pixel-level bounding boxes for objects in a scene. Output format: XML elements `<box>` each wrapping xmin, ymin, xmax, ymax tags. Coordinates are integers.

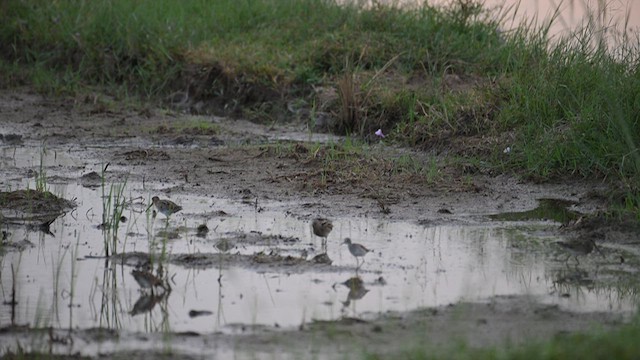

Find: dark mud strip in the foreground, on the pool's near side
<box><xmin>0</xmin><ymin>296</ymin><xmax>624</xmax><ymax>359</ymax></box>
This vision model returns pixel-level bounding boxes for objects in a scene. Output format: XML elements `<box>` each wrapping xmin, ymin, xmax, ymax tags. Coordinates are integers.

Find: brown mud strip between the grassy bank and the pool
<box><xmin>0</xmin><ymin>90</ymin><xmax>608</xmax><ymax>221</ymax></box>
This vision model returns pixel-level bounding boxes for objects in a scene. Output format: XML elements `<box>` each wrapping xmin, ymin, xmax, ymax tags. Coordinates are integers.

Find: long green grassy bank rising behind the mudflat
<box><xmin>0</xmin><ymin>0</ymin><xmax>640</xmax><ymax>214</ymax></box>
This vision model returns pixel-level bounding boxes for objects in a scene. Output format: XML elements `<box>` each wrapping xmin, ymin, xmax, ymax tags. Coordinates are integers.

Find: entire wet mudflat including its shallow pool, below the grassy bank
<box><xmin>0</xmin><ymin>89</ymin><xmax>640</xmax><ymax>359</ymax></box>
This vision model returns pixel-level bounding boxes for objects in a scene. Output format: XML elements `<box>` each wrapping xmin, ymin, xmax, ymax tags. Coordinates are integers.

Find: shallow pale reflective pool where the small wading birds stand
<box><xmin>0</xmin><ymin>148</ymin><xmax>636</xmax><ymax>333</ymax></box>
